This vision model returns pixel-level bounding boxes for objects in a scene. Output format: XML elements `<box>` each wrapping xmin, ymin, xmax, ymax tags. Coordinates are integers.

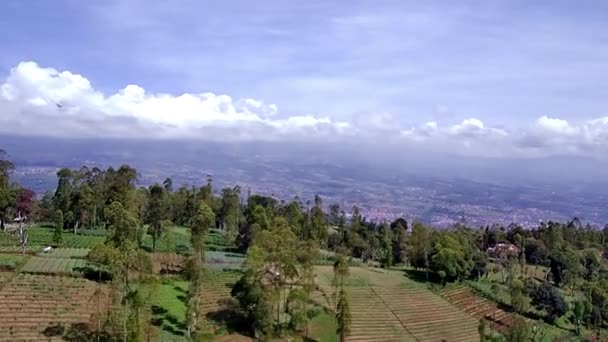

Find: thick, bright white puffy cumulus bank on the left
<box><xmin>0</xmin><ymin>62</ymin><xmax>349</xmax><ymax>140</ymax></box>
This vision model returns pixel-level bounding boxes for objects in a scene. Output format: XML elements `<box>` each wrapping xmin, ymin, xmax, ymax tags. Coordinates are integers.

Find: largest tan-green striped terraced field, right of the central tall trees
<box><xmin>315</xmin><ymin>266</ymin><xmax>479</xmax><ymax>342</ymax></box>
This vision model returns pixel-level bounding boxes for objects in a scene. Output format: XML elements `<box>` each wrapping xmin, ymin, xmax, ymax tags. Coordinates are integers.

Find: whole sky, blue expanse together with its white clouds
<box><xmin>0</xmin><ymin>0</ymin><xmax>608</xmax><ymax>158</ymax></box>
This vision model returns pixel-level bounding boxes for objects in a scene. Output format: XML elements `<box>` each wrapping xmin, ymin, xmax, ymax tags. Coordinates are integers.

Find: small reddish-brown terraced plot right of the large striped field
<box><xmin>440</xmin><ymin>287</ymin><xmax>513</xmax><ymax>331</ymax></box>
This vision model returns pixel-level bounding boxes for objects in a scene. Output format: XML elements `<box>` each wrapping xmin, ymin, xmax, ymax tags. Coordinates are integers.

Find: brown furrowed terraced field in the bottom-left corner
<box><xmin>0</xmin><ymin>275</ymin><xmax>105</xmax><ymax>341</ymax></box>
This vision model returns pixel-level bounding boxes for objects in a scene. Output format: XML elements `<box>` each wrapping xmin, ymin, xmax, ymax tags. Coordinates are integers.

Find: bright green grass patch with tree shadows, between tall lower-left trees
<box><xmin>152</xmin><ymin>278</ymin><xmax>188</xmax><ymax>341</ymax></box>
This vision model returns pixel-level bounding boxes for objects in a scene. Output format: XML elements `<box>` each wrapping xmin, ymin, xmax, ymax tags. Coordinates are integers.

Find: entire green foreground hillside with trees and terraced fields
<box><xmin>0</xmin><ymin>153</ymin><xmax>608</xmax><ymax>341</ymax></box>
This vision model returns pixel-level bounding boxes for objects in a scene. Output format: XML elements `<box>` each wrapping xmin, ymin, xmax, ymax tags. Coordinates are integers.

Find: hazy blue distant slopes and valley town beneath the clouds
<box><xmin>0</xmin><ymin>136</ymin><xmax>608</xmax><ymax>226</ymax></box>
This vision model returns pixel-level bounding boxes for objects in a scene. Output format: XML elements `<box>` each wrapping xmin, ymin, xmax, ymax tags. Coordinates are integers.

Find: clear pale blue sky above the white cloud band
<box><xmin>0</xmin><ymin>0</ymin><xmax>608</xmax><ymax>158</ymax></box>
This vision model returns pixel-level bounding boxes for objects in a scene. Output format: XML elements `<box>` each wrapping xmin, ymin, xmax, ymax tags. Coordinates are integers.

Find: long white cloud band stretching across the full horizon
<box><xmin>0</xmin><ymin>62</ymin><xmax>608</xmax><ymax>158</ymax></box>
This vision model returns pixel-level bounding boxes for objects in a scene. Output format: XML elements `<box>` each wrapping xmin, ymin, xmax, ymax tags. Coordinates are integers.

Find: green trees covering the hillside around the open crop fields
<box><xmin>0</xmin><ymin>152</ymin><xmax>608</xmax><ymax>341</ymax></box>
